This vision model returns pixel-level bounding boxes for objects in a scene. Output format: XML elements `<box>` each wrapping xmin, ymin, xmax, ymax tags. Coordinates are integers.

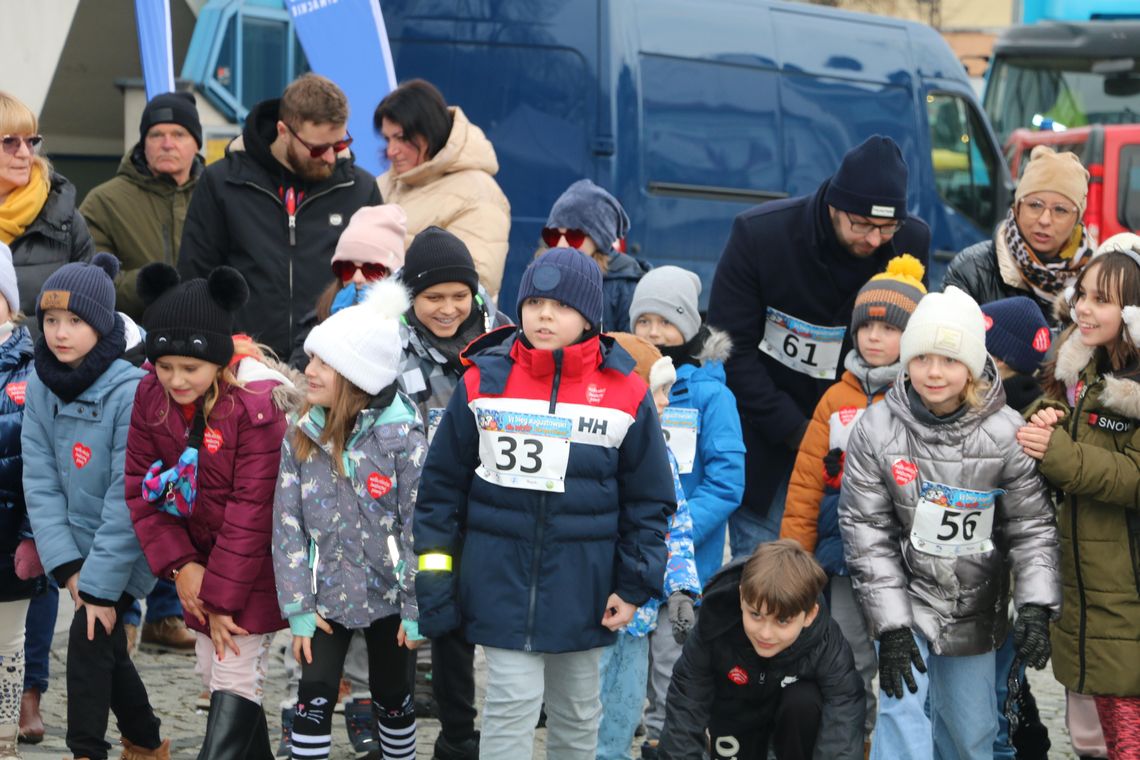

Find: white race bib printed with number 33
<box><xmin>475</xmin><ymin>408</ymin><xmax>573</xmax><ymax>493</ymax></box>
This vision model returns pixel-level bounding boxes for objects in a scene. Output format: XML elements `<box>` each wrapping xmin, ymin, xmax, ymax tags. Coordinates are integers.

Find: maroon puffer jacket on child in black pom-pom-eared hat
<box><xmin>125</xmin><ymin>359</ymin><xmax>298</xmax><ymax>634</ymax></box>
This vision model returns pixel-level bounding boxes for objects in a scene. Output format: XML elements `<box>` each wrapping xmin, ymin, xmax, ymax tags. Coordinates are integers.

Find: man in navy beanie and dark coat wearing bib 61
<box><xmin>708</xmin><ymin>134</ymin><xmax>930</xmax><ymax>558</ymax></box>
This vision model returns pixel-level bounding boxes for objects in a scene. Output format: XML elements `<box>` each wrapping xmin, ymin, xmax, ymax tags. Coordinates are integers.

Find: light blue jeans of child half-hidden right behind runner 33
<box><xmin>597</xmin><ymin>634</ymin><xmax>649</xmax><ymax>760</ymax></box>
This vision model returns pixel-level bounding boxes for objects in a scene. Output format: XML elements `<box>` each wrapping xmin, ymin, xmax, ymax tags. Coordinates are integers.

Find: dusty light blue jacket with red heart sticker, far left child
<box><xmin>22</xmin><ymin>359</ymin><xmax>155</xmax><ymax>605</ymax></box>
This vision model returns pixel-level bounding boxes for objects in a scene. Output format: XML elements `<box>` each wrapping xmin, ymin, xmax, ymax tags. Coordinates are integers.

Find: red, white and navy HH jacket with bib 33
<box><xmin>413</xmin><ymin>327</ymin><xmax>676</xmax><ymax>653</ymax></box>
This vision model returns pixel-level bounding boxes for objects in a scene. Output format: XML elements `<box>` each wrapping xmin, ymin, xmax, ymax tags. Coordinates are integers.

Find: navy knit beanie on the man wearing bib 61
<box><xmin>823</xmin><ymin>134</ymin><xmax>906</xmax><ymax>219</ymax></box>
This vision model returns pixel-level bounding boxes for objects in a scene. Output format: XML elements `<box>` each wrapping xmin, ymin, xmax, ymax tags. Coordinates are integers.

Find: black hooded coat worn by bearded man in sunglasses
<box><xmin>178</xmin><ymin>100</ymin><xmax>381</xmax><ymax>357</ymax></box>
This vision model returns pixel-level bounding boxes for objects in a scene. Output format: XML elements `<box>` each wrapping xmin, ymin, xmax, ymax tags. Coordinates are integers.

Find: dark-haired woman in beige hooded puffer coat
<box><xmin>373</xmin><ymin>79</ymin><xmax>511</xmax><ymax>299</ymax></box>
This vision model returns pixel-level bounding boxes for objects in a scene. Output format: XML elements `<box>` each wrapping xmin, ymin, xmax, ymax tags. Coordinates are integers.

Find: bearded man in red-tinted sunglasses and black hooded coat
<box><xmin>178</xmin><ymin>74</ymin><xmax>381</xmax><ymax>357</ymax></box>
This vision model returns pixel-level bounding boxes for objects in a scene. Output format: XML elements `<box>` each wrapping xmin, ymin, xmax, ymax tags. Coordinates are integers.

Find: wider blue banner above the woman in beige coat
<box><xmin>285</xmin><ymin>0</ymin><xmax>396</xmax><ymax>174</ymax></box>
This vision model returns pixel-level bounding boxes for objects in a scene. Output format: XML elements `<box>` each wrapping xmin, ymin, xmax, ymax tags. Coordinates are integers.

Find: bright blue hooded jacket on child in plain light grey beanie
<box><xmin>669</xmin><ymin>329</ymin><xmax>744</xmax><ymax>583</ymax></box>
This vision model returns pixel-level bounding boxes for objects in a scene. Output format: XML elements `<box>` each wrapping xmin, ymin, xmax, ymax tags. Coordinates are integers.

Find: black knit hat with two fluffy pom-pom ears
<box><xmin>138</xmin><ymin>263</ymin><xmax>250</xmax><ymax>367</ymax></box>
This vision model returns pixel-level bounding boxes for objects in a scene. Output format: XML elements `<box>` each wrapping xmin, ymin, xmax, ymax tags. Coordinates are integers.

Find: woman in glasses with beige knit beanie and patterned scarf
<box><xmin>943</xmin><ymin>145</ymin><xmax>1097</xmax><ymax>327</ymax></box>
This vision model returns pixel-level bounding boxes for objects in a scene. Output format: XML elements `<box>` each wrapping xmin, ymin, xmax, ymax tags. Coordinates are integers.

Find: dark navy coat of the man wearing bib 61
<box><xmin>708</xmin><ymin>180</ymin><xmax>930</xmax><ymax>515</ymax></box>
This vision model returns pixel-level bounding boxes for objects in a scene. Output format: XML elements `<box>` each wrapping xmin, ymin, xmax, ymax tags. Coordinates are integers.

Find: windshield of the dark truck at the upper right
<box><xmin>985</xmin><ymin>56</ymin><xmax>1140</xmax><ymax>144</ymax></box>
